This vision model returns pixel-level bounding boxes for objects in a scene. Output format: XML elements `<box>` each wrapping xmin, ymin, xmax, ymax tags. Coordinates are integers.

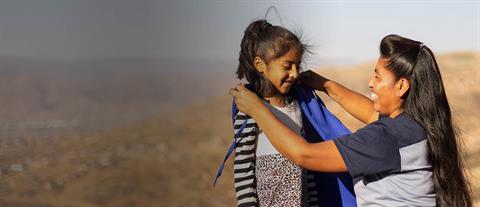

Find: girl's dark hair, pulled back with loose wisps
<box><xmin>237</xmin><ymin>19</ymin><xmax>309</xmax><ymax>97</ymax></box>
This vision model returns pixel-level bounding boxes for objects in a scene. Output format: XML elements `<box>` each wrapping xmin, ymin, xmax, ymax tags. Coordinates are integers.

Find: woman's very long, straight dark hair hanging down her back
<box><xmin>380</xmin><ymin>35</ymin><xmax>472</xmax><ymax>207</ymax></box>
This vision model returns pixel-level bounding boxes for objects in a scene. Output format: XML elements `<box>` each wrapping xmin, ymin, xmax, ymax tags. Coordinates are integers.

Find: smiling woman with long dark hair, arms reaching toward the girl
<box><xmin>230</xmin><ymin>35</ymin><xmax>472</xmax><ymax>207</ymax></box>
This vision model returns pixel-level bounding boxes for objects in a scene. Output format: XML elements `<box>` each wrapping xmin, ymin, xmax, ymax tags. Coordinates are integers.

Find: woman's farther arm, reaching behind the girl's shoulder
<box><xmin>300</xmin><ymin>70</ymin><xmax>378</xmax><ymax>124</ymax></box>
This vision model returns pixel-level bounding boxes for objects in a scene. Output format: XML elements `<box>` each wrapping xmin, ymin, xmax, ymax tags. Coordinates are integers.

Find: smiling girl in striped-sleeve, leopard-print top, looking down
<box><xmin>217</xmin><ymin>20</ymin><xmax>355</xmax><ymax>206</ymax></box>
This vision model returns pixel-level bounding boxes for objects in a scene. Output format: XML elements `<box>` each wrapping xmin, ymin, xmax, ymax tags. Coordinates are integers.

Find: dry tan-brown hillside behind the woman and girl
<box><xmin>0</xmin><ymin>52</ymin><xmax>480</xmax><ymax>207</ymax></box>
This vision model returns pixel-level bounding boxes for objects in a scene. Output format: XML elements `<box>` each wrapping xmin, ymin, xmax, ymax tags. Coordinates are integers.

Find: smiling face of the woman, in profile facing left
<box><xmin>368</xmin><ymin>57</ymin><xmax>403</xmax><ymax>116</ymax></box>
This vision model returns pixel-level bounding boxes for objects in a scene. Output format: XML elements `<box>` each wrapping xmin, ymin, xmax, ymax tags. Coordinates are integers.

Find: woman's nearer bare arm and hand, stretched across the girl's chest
<box><xmin>229</xmin><ymin>85</ymin><xmax>347</xmax><ymax>172</ymax></box>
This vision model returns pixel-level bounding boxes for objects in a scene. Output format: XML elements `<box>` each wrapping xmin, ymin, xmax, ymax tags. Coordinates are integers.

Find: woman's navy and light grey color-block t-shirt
<box><xmin>334</xmin><ymin>113</ymin><xmax>436</xmax><ymax>206</ymax></box>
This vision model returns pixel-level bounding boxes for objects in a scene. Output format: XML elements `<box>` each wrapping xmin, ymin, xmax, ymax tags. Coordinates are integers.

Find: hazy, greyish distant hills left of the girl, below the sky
<box><xmin>0</xmin><ymin>57</ymin><xmax>234</xmax><ymax>138</ymax></box>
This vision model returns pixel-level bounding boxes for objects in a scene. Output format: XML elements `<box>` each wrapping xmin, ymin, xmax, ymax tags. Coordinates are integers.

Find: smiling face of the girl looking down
<box><xmin>264</xmin><ymin>50</ymin><xmax>302</xmax><ymax>94</ymax></box>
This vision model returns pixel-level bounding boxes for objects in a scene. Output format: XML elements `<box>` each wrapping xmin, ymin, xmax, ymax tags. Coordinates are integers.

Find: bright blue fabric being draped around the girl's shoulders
<box><xmin>214</xmin><ymin>86</ymin><xmax>357</xmax><ymax>207</ymax></box>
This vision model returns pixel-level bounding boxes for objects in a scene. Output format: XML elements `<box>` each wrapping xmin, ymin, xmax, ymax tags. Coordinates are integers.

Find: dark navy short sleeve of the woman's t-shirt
<box><xmin>334</xmin><ymin>120</ymin><xmax>401</xmax><ymax>178</ymax></box>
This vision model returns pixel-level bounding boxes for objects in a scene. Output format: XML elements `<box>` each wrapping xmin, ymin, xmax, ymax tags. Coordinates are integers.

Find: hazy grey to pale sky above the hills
<box><xmin>0</xmin><ymin>0</ymin><xmax>480</xmax><ymax>64</ymax></box>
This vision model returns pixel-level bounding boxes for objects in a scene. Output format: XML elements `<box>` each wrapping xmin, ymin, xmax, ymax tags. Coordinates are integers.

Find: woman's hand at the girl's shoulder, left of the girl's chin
<box><xmin>228</xmin><ymin>83</ymin><xmax>268</xmax><ymax>117</ymax></box>
